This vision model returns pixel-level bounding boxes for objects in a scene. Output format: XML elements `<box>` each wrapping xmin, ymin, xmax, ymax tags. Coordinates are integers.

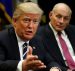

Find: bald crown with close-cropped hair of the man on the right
<box><xmin>52</xmin><ymin>3</ymin><xmax>72</xmax><ymax>15</ymax></box>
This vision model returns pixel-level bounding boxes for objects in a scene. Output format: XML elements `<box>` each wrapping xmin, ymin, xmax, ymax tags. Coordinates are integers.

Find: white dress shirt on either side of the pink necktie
<box><xmin>49</xmin><ymin>23</ymin><xmax>75</xmax><ymax>64</ymax></box>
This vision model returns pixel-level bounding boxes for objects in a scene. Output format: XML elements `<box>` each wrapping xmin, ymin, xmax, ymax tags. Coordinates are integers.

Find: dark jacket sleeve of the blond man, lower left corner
<box><xmin>0</xmin><ymin>44</ymin><xmax>19</xmax><ymax>71</ymax></box>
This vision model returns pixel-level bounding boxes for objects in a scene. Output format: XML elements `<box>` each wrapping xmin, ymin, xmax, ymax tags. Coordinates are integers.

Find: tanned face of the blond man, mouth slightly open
<box><xmin>14</xmin><ymin>13</ymin><xmax>41</xmax><ymax>41</ymax></box>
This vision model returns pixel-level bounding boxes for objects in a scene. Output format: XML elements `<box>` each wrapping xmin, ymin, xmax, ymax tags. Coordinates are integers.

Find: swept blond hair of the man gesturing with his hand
<box><xmin>13</xmin><ymin>2</ymin><xmax>43</xmax><ymax>18</ymax></box>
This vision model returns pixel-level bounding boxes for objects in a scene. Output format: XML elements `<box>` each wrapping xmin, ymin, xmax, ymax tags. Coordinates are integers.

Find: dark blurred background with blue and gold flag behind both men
<box><xmin>0</xmin><ymin>0</ymin><xmax>75</xmax><ymax>30</ymax></box>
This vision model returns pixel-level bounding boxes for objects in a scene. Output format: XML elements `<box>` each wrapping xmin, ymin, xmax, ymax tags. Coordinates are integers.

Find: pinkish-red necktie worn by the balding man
<box><xmin>58</xmin><ymin>34</ymin><xmax>75</xmax><ymax>70</ymax></box>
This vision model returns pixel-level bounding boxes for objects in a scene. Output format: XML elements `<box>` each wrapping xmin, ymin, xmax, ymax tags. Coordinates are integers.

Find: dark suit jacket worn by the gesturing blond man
<box><xmin>0</xmin><ymin>27</ymin><xmax>57</xmax><ymax>71</ymax></box>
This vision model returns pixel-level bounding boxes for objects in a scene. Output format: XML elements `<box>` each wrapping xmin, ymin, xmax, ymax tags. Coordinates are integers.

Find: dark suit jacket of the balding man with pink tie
<box><xmin>37</xmin><ymin>25</ymin><xmax>75</xmax><ymax>71</ymax></box>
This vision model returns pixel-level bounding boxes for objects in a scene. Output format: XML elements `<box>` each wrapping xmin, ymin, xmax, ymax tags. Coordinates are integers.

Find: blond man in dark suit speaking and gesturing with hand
<box><xmin>0</xmin><ymin>2</ymin><xmax>59</xmax><ymax>71</ymax></box>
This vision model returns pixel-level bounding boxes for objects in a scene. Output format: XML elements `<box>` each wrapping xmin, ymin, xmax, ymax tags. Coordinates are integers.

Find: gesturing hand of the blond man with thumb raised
<box><xmin>22</xmin><ymin>46</ymin><xmax>46</xmax><ymax>71</ymax></box>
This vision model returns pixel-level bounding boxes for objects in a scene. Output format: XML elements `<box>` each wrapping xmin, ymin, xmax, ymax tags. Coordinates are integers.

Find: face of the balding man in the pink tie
<box><xmin>49</xmin><ymin>8</ymin><xmax>71</xmax><ymax>31</ymax></box>
